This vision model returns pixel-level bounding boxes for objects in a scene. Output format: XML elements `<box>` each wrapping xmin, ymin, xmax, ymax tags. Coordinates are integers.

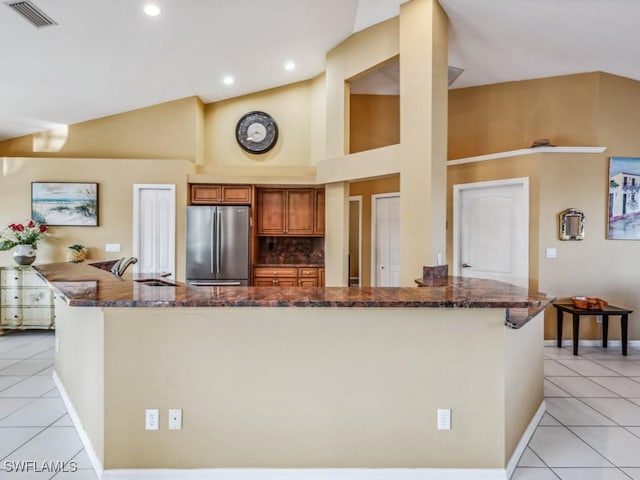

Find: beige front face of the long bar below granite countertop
<box><xmin>56</xmin><ymin>308</ymin><xmax>528</xmax><ymax>469</ymax></box>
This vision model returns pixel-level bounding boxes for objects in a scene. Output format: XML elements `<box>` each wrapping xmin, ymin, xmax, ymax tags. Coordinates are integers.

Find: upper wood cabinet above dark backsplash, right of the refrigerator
<box><xmin>257</xmin><ymin>188</ymin><xmax>324</xmax><ymax>236</ymax></box>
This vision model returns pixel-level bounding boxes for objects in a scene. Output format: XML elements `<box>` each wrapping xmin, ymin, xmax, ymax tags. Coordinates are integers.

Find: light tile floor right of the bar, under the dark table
<box><xmin>511</xmin><ymin>346</ymin><xmax>640</xmax><ymax>480</ymax></box>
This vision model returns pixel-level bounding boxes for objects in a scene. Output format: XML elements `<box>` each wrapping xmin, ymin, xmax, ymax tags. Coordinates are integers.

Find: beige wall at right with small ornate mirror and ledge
<box><xmin>447</xmin><ymin>73</ymin><xmax>640</xmax><ymax>339</ymax></box>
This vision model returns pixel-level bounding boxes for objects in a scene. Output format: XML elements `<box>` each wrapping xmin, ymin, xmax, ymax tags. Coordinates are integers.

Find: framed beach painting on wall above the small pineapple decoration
<box><xmin>31</xmin><ymin>182</ymin><xmax>98</xmax><ymax>227</ymax></box>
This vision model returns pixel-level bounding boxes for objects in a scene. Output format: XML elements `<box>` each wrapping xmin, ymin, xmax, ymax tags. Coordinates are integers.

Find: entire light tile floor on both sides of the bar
<box><xmin>0</xmin><ymin>331</ymin><xmax>640</xmax><ymax>480</ymax></box>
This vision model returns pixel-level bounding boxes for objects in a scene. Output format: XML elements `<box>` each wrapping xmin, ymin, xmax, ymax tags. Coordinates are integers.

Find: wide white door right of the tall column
<box><xmin>453</xmin><ymin>178</ymin><xmax>529</xmax><ymax>287</ymax></box>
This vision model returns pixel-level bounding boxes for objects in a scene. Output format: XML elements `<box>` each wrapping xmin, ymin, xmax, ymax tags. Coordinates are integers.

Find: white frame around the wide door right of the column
<box><xmin>453</xmin><ymin>177</ymin><xmax>530</xmax><ymax>284</ymax></box>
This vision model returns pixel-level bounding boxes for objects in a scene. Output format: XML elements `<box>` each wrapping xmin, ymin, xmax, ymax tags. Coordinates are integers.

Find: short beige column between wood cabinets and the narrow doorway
<box><xmin>324</xmin><ymin>182</ymin><xmax>349</xmax><ymax>287</ymax></box>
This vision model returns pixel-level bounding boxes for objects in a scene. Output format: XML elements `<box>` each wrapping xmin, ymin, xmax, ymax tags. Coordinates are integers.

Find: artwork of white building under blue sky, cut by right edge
<box><xmin>607</xmin><ymin>157</ymin><xmax>640</xmax><ymax>240</ymax></box>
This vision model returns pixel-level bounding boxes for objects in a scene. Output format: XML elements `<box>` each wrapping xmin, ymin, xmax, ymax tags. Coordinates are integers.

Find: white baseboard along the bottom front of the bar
<box><xmin>102</xmin><ymin>468</ymin><xmax>508</xmax><ymax>480</ymax></box>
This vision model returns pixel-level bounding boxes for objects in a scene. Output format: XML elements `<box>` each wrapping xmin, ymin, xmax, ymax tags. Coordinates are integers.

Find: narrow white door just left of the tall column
<box><xmin>371</xmin><ymin>193</ymin><xmax>400</xmax><ymax>287</ymax></box>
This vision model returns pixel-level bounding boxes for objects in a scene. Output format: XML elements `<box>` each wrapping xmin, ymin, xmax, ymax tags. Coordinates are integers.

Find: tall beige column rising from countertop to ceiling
<box><xmin>400</xmin><ymin>0</ymin><xmax>448</xmax><ymax>286</ymax></box>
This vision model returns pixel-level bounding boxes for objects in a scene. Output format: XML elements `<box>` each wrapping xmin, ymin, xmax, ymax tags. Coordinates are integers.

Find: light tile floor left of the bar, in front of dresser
<box><xmin>0</xmin><ymin>330</ymin><xmax>96</xmax><ymax>480</ymax></box>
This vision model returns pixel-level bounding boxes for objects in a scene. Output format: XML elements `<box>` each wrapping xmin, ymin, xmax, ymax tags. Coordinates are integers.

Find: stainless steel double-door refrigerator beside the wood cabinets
<box><xmin>186</xmin><ymin>206</ymin><xmax>251</xmax><ymax>286</ymax></box>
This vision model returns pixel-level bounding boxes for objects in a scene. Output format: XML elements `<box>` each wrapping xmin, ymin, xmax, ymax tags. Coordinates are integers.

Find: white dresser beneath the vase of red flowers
<box><xmin>0</xmin><ymin>267</ymin><xmax>55</xmax><ymax>335</ymax></box>
